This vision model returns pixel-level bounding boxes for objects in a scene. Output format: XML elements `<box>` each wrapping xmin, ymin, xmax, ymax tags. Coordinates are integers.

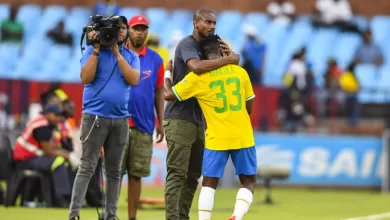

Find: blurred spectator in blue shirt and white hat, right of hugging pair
<box><xmin>242</xmin><ymin>25</ymin><xmax>266</xmax><ymax>85</ymax></box>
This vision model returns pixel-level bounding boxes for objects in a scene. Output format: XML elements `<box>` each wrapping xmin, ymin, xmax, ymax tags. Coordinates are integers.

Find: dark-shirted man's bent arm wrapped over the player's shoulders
<box><xmin>180</xmin><ymin>44</ymin><xmax>240</xmax><ymax>74</ymax></box>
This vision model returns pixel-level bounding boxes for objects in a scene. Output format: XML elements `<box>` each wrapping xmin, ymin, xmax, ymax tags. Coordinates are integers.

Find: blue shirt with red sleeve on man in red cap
<box><xmin>129</xmin><ymin>47</ymin><xmax>164</xmax><ymax>134</ymax></box>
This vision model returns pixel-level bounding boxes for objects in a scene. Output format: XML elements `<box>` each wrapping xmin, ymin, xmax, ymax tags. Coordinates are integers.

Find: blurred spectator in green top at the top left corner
<box><xmin>0</xmin><ymin>4</ymin><xmax>24</xmax><ymax>43</ymax></box>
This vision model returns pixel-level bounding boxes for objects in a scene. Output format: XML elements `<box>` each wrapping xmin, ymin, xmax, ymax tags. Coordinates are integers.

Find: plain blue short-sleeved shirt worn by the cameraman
<box><xmin>81</xmin><ymin>46</ymin><xmax>140</xmax><ymax>118</ymax></box>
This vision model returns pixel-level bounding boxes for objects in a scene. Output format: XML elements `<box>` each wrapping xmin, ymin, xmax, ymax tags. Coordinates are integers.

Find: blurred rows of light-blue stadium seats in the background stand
<box><xmin>0</xmin><ymin>4</ymin><xmax>390</xmax><ymax>103</ymax></box>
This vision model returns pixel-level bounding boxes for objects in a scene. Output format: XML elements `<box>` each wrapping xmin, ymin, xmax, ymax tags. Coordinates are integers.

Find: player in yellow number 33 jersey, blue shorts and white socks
<box><xmin>165</xmin><ymin>35</ymin><xmax>257</xmax><ymax>220</ymax></box>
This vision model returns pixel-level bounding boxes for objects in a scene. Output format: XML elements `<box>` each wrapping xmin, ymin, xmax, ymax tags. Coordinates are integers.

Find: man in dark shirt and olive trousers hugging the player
<box><xmin>163</xmin><ymin>9</ymin><xmax>239</xmax><ymax>220</ymax></box>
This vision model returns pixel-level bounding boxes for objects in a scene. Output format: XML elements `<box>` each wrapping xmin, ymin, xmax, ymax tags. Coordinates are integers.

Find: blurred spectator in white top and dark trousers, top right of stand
<box><xmin>313</xmin><ymin>0</ymin><xmax>360</xmax><ymax>33</ymax></box>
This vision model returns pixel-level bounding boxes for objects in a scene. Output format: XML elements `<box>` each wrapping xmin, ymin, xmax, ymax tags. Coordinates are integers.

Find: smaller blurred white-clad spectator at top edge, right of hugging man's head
<box><xmin>267</xmin><ymin>0</ymin><xmax>295</xmax><ymax>25</ymax></box>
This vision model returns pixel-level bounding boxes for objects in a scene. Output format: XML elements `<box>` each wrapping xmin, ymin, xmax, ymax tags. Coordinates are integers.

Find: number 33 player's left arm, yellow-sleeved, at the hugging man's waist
<box><xmin>164</xmin><ymin>71</ymin><xmax>200</xmax><ymax>101</ymax></box>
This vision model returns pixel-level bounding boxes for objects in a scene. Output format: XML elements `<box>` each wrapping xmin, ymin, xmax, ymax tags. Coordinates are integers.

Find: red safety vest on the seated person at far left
<box><xmin>13</xmin><ymin>115</ymin><xmax>49</xmax><ymax>160</ymax></box>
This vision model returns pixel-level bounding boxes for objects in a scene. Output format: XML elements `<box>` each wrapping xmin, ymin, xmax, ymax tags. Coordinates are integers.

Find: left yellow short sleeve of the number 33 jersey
<box><xmin>172</xmin><ymin>72</ymin><xmax>199</xmax><ymax>101</ymax></box>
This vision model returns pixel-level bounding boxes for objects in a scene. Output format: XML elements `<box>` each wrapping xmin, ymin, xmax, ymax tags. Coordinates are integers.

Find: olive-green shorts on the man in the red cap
<box><xmin>122</xmin><ymin>128</ymin><xmax>153</xmax><ymax>178</ymax></box>
